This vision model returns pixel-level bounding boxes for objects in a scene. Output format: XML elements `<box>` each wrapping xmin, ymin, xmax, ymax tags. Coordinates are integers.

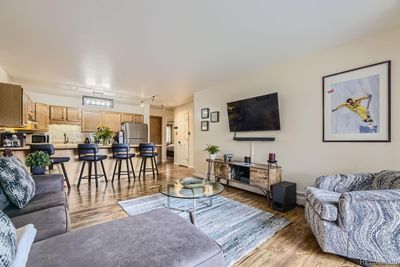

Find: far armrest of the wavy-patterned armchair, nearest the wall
<box><xmin>314</xmin><ymin>173</ymin><xmax>374</xmax><ymax>193</ymax></box>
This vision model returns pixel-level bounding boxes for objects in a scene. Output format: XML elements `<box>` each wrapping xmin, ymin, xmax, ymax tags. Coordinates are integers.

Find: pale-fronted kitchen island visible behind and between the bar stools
<box><xmin>0</xmin><ymin>144</ymin><xmax>162</xmax><ymax>185</ymax></box>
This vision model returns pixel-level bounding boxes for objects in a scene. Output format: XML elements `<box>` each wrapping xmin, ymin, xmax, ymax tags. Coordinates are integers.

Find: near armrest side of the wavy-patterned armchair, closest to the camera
<box><xmin>338</xmin><ymin>189</ymin><xmax>400</xmax><ymax>264</ymax></box>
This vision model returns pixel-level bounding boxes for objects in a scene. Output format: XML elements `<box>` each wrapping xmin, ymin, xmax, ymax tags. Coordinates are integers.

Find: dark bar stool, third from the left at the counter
<box><xmin>111</xmin><ymin>143</ymin><xmax>136</xmax><ymax>183</ymax></box>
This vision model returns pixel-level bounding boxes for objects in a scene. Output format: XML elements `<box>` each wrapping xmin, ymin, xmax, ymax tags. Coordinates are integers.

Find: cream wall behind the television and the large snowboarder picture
<box><xmin>194</xmin><ymin>24</ymin><xmax>400</xmax><ymax>192</ymax></box>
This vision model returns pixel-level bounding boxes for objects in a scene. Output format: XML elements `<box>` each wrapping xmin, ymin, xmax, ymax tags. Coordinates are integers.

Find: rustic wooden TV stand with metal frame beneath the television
<box><xmin>207</xmin><ymin>159</ymin><xmax>282</xmax><ymax>204</ymax></box>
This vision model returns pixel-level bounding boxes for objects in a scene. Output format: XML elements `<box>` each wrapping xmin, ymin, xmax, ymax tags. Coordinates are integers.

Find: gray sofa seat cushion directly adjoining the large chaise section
<box><xmin>11</xmin><ymin>206</ymin><xmax>70</xmax><ymax>242</ymax></box>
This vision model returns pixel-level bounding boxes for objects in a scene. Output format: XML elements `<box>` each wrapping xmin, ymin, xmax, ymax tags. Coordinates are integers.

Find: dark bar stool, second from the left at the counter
<box><xmin>77</xmin><ymin>144</ymin><xmax>108</xmax><ymax>188</ymax></box>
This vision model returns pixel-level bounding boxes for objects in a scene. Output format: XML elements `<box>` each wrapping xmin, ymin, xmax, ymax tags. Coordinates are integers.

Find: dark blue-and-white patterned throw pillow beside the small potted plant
<box><xmin>0</xmin><ymin>157</ymin><xmax>35</xmax><ymax>209</ymax></box>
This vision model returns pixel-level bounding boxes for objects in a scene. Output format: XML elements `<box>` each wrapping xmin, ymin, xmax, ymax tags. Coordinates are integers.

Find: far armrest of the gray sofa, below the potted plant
<box><xmin>33</xmin><ymin>174</ymin><xmax>64</xmax><ymax>195</ymax></box>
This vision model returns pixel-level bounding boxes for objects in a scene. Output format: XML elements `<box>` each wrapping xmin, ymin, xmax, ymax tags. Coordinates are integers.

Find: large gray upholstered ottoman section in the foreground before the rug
<box><xmin>27</xmin><ymin>209</ymin><xmax>224</xmax><ymax>267</ymax></box>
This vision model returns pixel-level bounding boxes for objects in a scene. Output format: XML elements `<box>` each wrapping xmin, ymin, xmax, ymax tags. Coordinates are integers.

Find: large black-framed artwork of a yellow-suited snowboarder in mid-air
<box><xmin>322</xmin><ymin>61</ymin><xmax>390</xmax><ymax>142</ymax></box>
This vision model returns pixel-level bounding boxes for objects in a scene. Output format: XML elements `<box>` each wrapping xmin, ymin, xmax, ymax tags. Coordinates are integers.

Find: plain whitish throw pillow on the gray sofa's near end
<box><xmin>12</xmin><ymin>224</ymin><xmax>36</xmax><ymax>267</ymax></box>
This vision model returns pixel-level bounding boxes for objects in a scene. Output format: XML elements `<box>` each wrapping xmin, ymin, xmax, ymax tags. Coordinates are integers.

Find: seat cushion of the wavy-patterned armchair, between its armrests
<box><xmin>305</xmin><ymin>187</ymin><xmax>341</xmax><ymax>221</ymax></box>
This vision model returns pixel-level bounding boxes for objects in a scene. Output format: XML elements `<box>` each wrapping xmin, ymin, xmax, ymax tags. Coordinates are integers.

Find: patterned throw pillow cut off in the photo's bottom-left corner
<box><xmin>0</xmin><ymin>211</ymin><xmax>17</xmax><ymax>267</ymax></box>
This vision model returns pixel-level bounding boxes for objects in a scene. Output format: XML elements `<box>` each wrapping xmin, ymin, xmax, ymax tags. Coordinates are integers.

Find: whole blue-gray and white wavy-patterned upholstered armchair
<box><xmin>305</xmin><ymin>171</ymin><xmax>400</xmax><ymax>264</ymax></box>
